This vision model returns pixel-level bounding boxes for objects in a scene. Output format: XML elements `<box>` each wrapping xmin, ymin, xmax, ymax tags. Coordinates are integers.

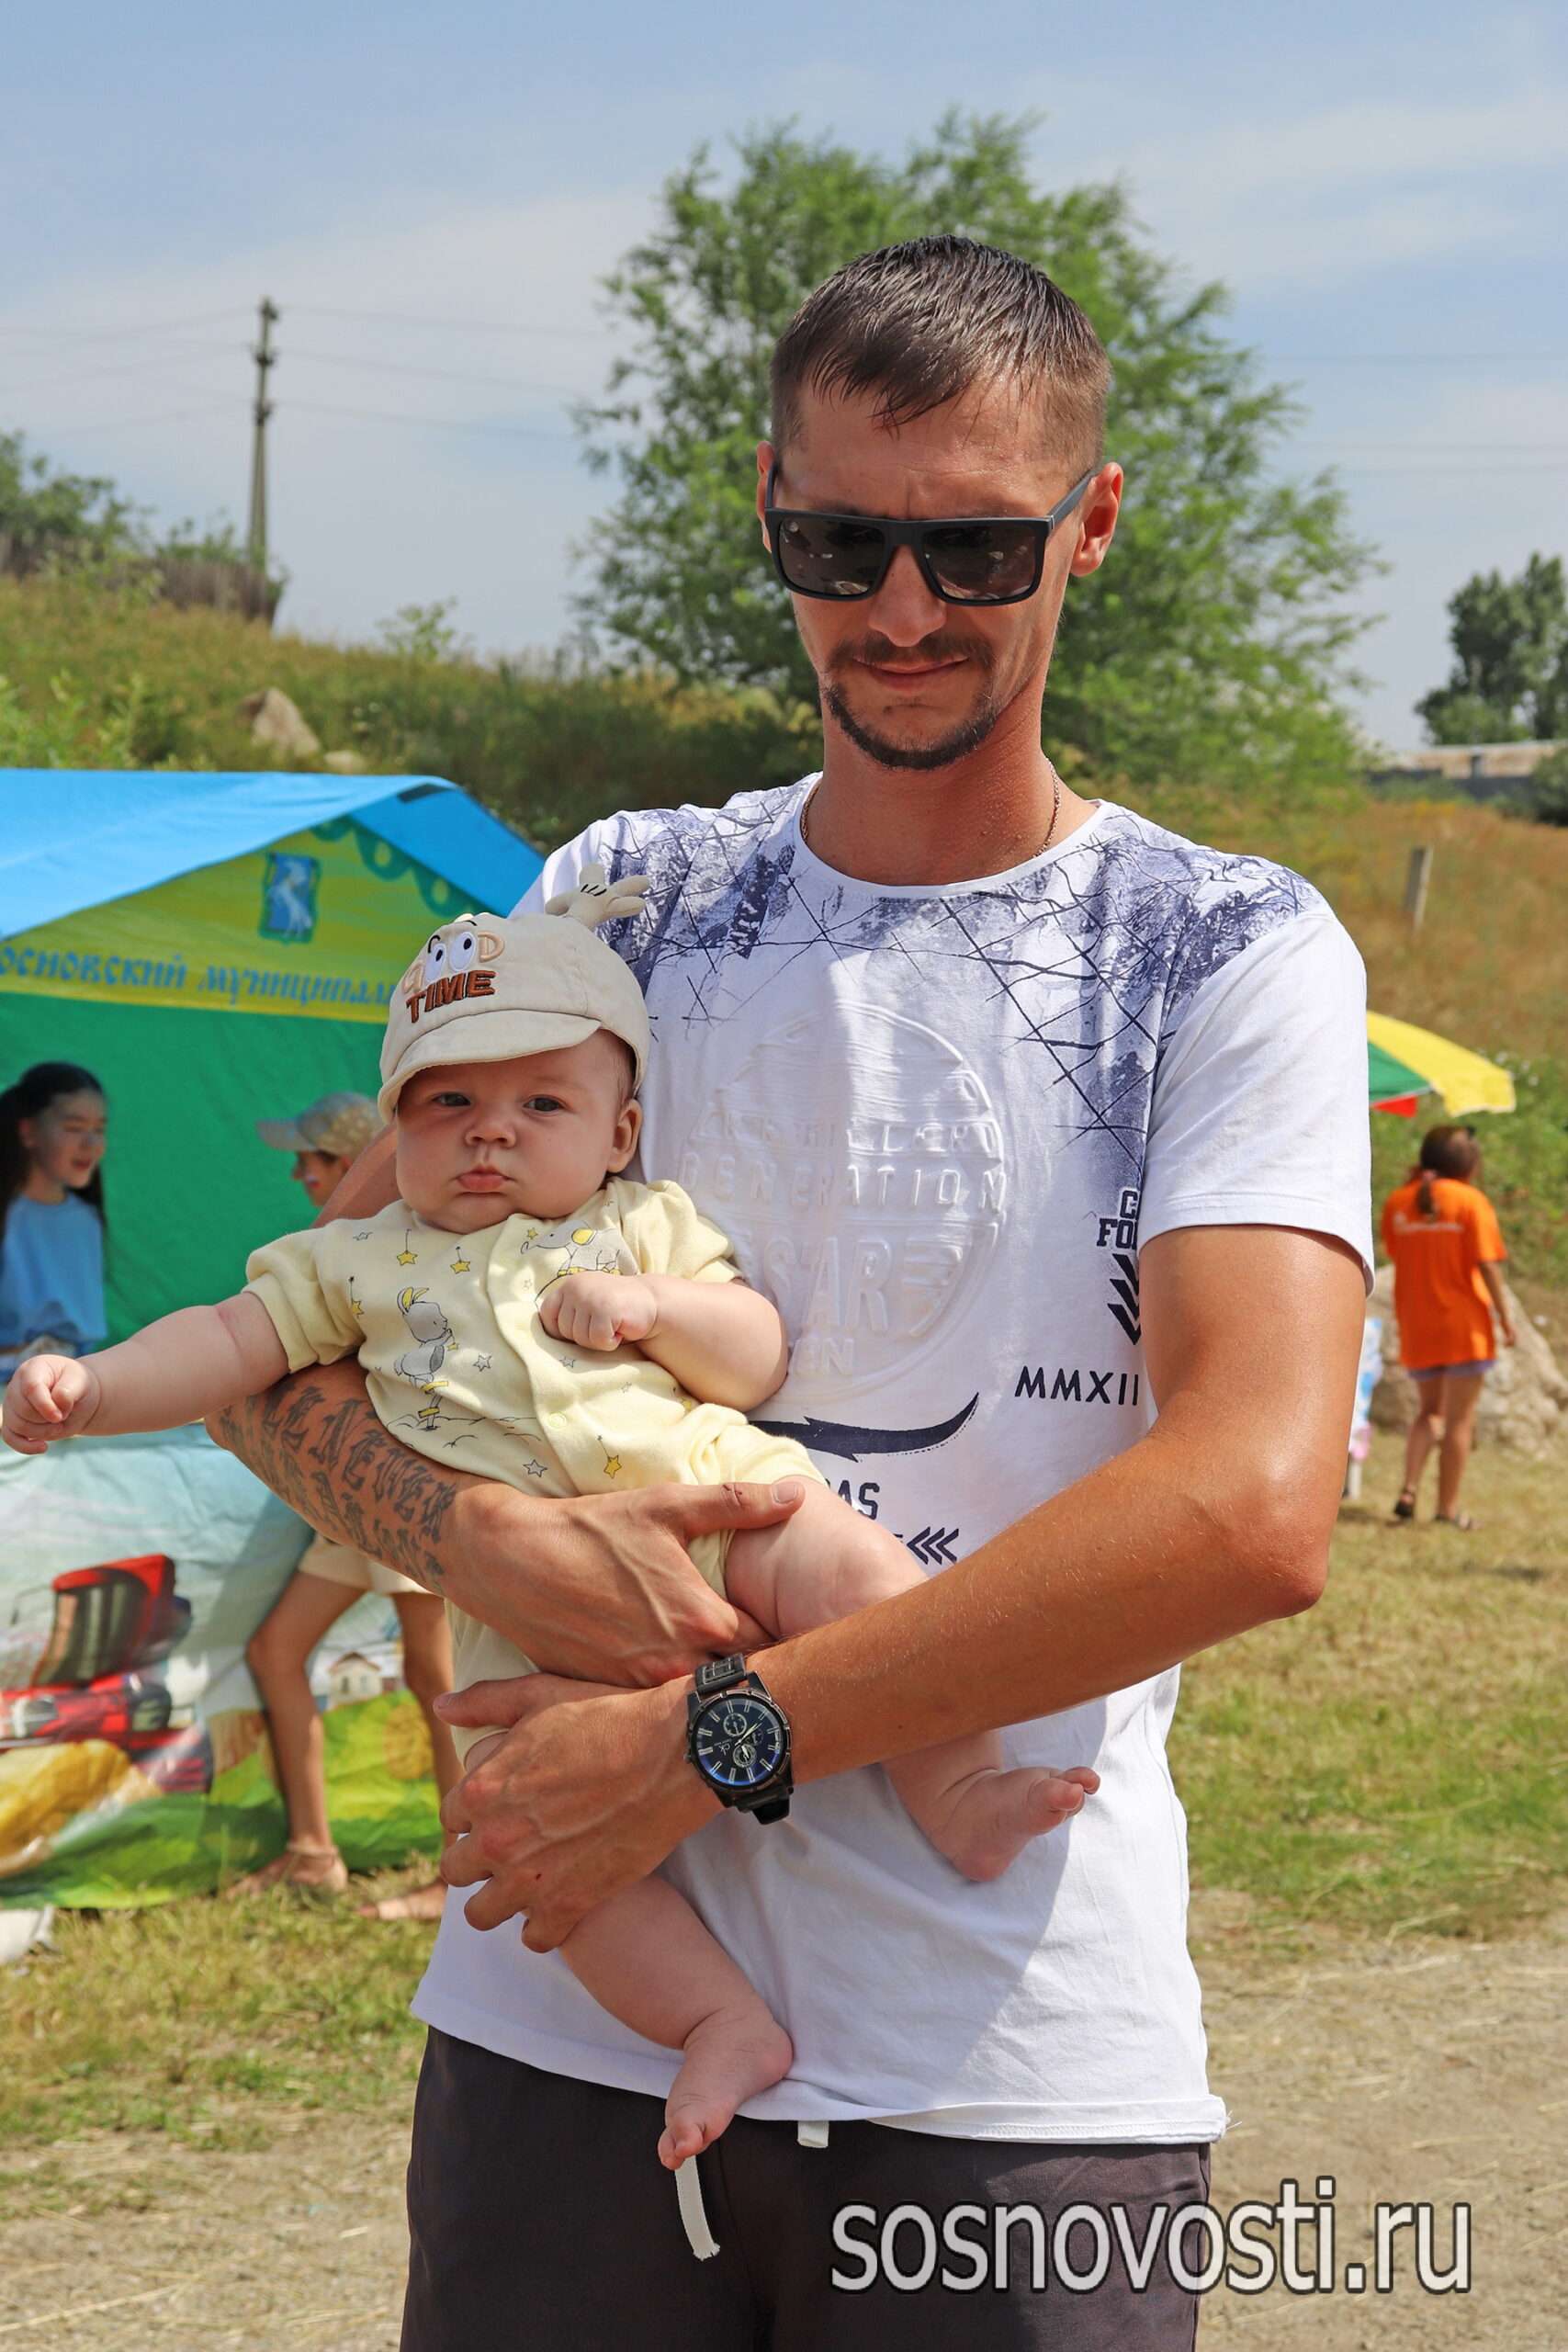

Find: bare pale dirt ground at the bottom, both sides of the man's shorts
<box><xmin>0</xmin><ymin>1895</ymin><xmax>1568</xmax><ymax>2352</ymax></box>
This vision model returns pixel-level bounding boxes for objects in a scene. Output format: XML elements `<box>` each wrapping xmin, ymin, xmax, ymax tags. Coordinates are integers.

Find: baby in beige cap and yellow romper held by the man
<box><xmin>5</xmin><ymin>868</ymin><xmax>1098</xmax><ymax>2166</ymax></box>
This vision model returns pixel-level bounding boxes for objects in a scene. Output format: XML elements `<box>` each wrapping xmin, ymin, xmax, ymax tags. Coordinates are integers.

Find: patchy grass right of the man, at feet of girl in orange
<box><xmin>1170</xmin><ymin>1435</ymin><xmax>1568</xmax><ymax>1936</ymax></box>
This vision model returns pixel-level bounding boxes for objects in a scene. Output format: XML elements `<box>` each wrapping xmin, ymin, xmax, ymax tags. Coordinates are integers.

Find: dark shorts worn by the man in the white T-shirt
<box><xmin>402</xmin><ymin>2032</ymin><xmax>1208</xmax><ymax>2352</ymax></box>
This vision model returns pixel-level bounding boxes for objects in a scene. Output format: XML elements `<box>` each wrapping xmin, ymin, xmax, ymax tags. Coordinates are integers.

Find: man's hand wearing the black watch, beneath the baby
<box><xmin>437</xmin><ymin>1675</ymin><xmax>719</xmax><ymax>1952</ymax></box>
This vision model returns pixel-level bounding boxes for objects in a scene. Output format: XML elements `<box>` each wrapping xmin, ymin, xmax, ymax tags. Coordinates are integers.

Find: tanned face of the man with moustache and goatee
<box><xmin>757</xmin><ymin>383</ymin><xmax>1122</xmax><ymax>769</ymax></box>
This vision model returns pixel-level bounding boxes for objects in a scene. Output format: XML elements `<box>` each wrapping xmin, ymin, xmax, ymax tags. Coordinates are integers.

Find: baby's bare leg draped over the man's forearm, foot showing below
<box><xmin>724</xmin><ymin>1484</ymin><xmax>1100</xmax><ymax>1879</ymax></box>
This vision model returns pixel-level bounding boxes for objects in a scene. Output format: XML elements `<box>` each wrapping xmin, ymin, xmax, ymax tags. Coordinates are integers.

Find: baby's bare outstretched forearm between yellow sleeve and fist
<box><xmin>75</xmin><ymin>1291</ymin><xmax>289</xmax><ymax>1437</ymax></box>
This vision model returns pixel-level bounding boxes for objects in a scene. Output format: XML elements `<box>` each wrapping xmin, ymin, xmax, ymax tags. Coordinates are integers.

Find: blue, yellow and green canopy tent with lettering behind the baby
<box><xmin>0</xmin><ymin>769</ymin><xmax>541</xmax><ymax>1336</ymax></box>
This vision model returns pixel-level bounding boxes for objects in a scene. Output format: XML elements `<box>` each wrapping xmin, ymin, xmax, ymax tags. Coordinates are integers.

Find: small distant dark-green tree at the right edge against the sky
<box><xmin>1416</xmin><ymin>555</ymin><xmax>1568</xmax><ymax>743</ymax></box>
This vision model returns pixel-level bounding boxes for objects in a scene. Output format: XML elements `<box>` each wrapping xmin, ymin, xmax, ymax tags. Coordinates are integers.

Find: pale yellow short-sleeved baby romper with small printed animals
<box><xmin>244</xmin><ymin>1176</ymin><xmax>825</xmax><ymax>1747</ymax></box>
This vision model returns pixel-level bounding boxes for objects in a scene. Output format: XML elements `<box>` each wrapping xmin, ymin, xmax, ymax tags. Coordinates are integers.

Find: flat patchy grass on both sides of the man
<box><xmin>0</xmin><ymin>1437</ymin><xmax>1568</xmax><ymax>2164</ymax></box>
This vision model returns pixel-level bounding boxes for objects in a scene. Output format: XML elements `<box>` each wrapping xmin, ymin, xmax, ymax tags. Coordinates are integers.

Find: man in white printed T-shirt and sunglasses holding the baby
<box><xmin>215</xmin><ymin>238</ymin><xmax>1371</xmax><ymax>2352</ymax></box>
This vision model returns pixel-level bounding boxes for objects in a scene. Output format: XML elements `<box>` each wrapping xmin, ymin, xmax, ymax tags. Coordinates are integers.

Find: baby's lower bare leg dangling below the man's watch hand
<box><xmin>463</xmin><ymin>1731</ymin><xmax>795</xmax><ymax>2171</ymax></box>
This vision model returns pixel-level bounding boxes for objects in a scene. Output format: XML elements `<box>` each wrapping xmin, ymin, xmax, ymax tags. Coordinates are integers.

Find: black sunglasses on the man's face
<box><xmin>761</xmin><ymin>461</ymin><xmax>1100</xmax><ymax>605</ymax></box>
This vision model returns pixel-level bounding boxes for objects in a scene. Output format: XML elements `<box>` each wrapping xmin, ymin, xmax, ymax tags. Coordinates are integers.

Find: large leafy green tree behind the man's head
<box><xmin>579</xmin><ymin>115</ymin><xmax>1373</xmax><ymax>778</ymax></box>
